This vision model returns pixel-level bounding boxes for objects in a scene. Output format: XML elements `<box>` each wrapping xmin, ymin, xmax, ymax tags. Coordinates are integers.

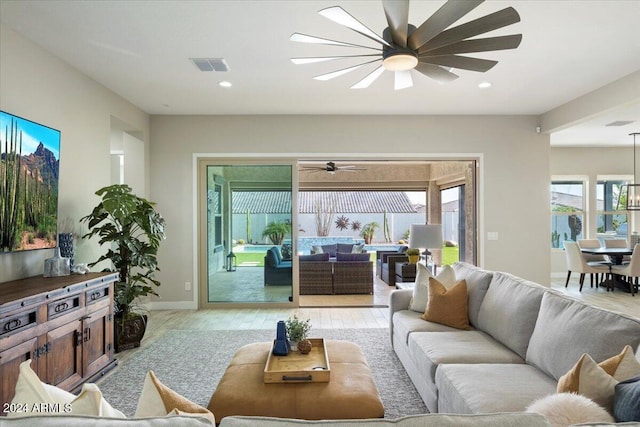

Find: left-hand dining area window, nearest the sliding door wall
<box><xmin>551</xmin><ymin>181</ymin><xmax>585</xmax><ymax>248</ymax></box>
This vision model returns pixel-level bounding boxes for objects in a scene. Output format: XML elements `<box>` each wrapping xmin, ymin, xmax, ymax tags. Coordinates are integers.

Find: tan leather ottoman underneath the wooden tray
<box><xmin>209</xmin><ymin>340</ymin><xmax>384</xmax><ymax>421</ymax></box>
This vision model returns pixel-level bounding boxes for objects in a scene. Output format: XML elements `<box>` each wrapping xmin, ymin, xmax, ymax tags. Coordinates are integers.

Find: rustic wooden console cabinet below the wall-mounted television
<box><xmin>0</xmin><ymin>273</ymin><xmax>118</xmax><ymax>415</ymax></box>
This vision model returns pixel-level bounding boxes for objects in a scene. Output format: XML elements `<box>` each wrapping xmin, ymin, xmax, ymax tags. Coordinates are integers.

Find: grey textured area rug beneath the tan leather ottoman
<box><xmin>97</xmin><ymin>328</ymin><xmax>428</xmax><ymax>418</ymax></box>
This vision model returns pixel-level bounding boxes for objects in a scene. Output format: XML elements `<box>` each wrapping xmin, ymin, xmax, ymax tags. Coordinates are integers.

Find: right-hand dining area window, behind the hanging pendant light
<box><xmin>596</xmin><ymin>179</ymin><xmax>628</xmax><ymax>238</ymax></box>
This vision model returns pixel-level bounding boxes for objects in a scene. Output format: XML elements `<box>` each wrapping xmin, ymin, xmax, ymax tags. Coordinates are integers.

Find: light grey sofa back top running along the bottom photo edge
<box><xmin>215</xmin><ymin>413</ymin><xmax>550</xmax><ymax>427</ymax></box>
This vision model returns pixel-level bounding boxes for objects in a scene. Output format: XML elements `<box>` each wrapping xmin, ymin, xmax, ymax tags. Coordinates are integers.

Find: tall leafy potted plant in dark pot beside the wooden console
<box><xmin>80</xmin><ymin>184</ymin><xmax>165</xmax><ymax>352</ymax></box>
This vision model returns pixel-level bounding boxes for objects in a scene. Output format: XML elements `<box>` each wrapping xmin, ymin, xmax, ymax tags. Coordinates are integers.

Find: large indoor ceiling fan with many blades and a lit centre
<box><xmin>290</xmin><ymin>0</ymin><xmax>522</xmax><ymax>90</ymax></box>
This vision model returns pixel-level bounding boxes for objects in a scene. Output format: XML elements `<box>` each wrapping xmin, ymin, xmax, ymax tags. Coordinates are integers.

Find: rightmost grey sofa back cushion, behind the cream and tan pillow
<box><xmin>526</xmin><ymin>290</ymin><xmax>640</xmax><ymax>380</ymax></box>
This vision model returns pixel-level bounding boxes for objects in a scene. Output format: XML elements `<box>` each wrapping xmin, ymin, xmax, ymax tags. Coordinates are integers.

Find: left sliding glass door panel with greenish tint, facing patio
<box><xmin>200</xmin><ymin>161</ymin><xmax>293</xmax><ymax>306</ymax></box>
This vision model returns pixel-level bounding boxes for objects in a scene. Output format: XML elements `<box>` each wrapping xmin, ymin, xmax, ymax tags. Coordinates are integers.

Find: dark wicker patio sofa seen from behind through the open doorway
<box><xmin>299</xmin><ymin>252</ymin><xmax>373</xmax><ymax>295</ymax></box>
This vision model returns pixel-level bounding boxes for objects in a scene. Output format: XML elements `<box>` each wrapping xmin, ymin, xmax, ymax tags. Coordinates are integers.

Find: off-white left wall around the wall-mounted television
<box><xmin>0</xmin><ymin>26</ymin><xmax>149</xmax><ymax>283</ymax></box>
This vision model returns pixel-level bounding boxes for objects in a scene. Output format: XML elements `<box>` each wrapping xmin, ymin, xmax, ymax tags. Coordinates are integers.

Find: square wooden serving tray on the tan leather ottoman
<box><xmin>264</xmin><ymin>338</ymin><xmax>331</xmax><ymax>383</ymax></box>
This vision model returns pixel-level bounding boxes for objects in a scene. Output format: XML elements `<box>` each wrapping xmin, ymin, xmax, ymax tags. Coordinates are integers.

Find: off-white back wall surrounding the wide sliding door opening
<box><xmin>151</xmin><ymin>116</ymin><xmax>550</xmax><ymax>301</ymax></box>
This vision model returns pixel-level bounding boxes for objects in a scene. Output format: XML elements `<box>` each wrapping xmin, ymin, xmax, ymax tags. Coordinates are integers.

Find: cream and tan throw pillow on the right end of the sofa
<box><xmin>557</xmin><ymin>346</ymin><xmax>640</xmax><ymax>413</ymax></box>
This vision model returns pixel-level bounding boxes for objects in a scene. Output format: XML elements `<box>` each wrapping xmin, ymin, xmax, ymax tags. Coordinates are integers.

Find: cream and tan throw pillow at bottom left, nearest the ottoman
<box><xmin>135</xmin><ymin>371</ymin><xmax>215</xmax><ymax>424</ymax></box>
